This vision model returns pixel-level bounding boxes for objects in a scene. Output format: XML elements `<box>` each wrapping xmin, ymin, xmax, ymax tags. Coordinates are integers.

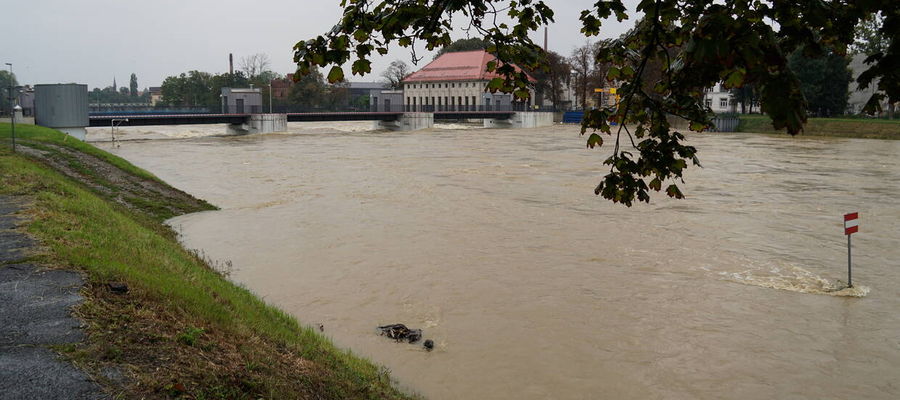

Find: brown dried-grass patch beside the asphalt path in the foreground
<box><xmin>61</xmin><ymin>284</ymin><xmax>338</xmax><ymax>399</ymax></box>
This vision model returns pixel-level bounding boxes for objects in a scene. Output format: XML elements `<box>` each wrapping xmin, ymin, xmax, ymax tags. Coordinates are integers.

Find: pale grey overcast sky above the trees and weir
<box><xmin>0</xmin><ymin>0</ymin><xmax>636</xmax><ymax>89</ymax></box>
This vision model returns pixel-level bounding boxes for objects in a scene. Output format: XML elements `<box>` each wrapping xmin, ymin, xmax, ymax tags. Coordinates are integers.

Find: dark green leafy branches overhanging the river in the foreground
<box><xmin>294</xmin><ymin>0</ymin><xmax>900</xmax><ymax>206</ymax></box>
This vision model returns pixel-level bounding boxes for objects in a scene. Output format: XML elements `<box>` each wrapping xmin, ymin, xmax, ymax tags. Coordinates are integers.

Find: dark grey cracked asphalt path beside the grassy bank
<box><xmin>0</xmin><ymin>196</ymin><xmax>107</xmax><ymax>400</ymax></box>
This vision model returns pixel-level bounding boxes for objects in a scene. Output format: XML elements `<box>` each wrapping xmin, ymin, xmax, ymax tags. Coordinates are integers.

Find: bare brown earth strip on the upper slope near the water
<box><xmin>20</xmin><ymin>142</ymin><xmax>215</xmax><ymax>221</ymax></box>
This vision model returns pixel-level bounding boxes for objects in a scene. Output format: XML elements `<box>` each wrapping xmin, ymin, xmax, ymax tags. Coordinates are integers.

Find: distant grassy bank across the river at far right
<box><xmin>737</xmin><ymin>115</ymin><xmax>900</xmax><ymax>139</ymax></box>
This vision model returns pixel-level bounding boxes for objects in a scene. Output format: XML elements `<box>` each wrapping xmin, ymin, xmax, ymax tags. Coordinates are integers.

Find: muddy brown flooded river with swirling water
<box><xmin>89</xmin><ymin>123</ymin><xmax>900</xmax><ymax>399</ymax></box>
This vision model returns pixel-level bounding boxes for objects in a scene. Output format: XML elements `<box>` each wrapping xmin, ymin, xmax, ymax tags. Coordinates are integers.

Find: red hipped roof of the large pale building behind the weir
<box><xmin>403</xmin><ymin>50</ymin><xmax>535</xmax><ymax>82</ymax></box>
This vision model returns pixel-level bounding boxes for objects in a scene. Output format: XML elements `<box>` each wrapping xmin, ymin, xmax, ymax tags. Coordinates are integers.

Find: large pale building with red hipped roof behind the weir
<box><xmin>402</xmin><ymin>50</ymin><xmax>535</xmax><ymax>111</ymax></box>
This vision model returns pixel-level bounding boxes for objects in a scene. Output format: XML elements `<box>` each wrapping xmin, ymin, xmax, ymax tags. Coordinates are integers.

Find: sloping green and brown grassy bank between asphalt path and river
<box><xmin>0</xmin><ymin>124</ymin><xmax>407</xmax><ymax>399</ymax></box>
